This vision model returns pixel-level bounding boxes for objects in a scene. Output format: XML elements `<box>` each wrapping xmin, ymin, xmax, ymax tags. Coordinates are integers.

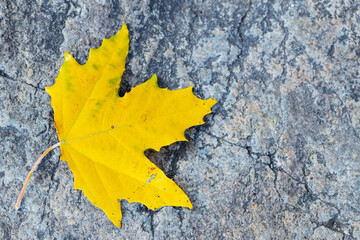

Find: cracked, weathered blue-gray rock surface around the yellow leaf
<box><xmin>0</xmin><ymin>0</ymin><xmax>360</xmax><ymax>239</ymax></box>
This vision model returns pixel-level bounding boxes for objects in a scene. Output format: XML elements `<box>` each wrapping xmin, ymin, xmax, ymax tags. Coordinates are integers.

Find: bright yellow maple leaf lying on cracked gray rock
<box><xmin>15</xmin><ymin>24</ymin><xmax>216</xmax><ymax>227</ymax></box>
